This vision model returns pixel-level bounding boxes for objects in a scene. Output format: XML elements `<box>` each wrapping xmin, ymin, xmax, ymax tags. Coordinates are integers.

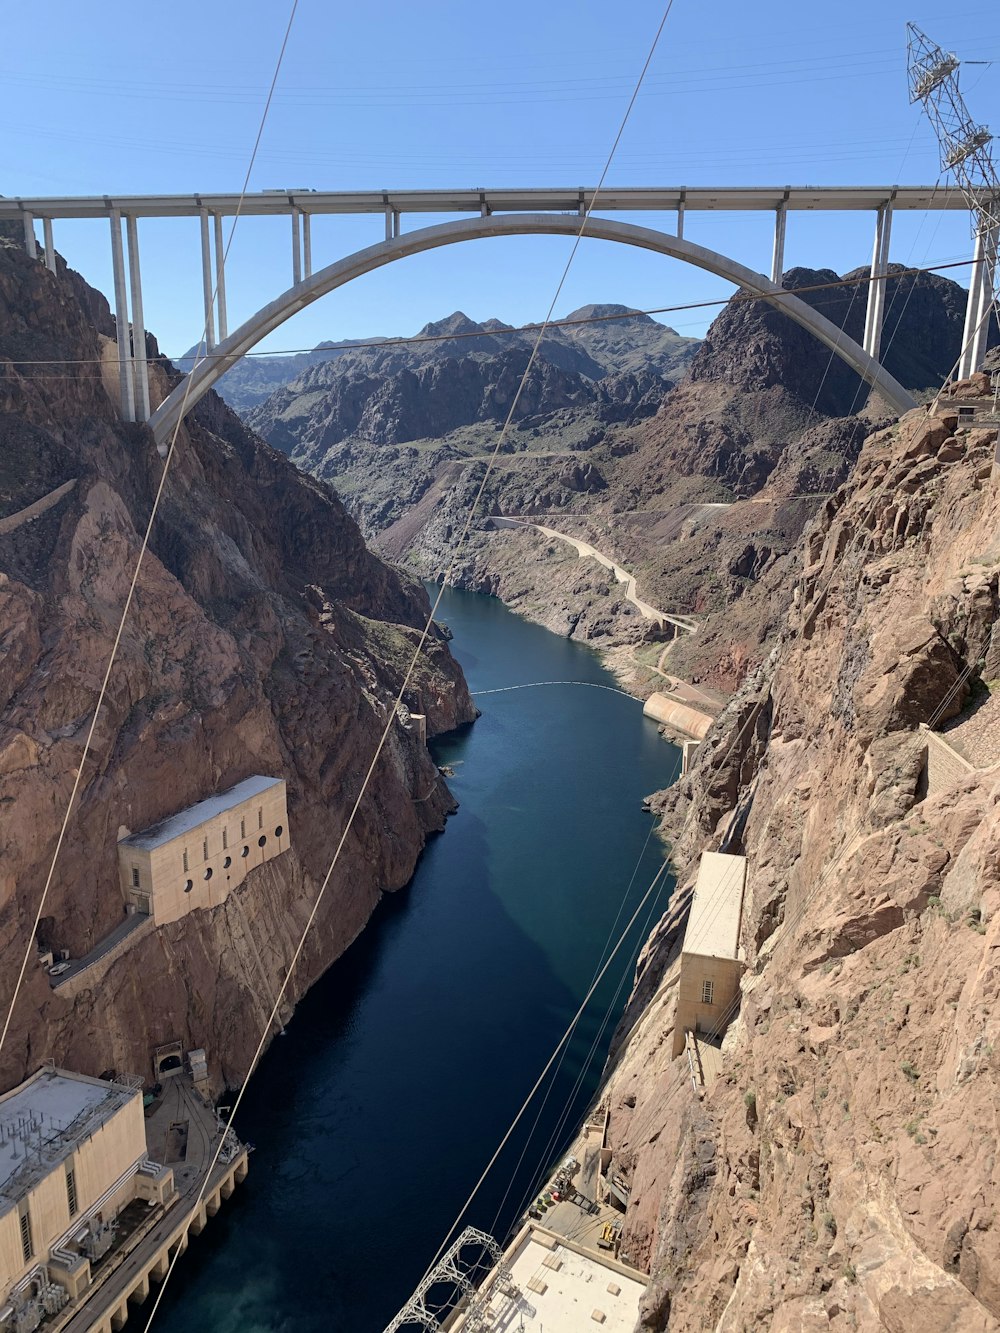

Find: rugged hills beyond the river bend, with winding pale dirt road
<box><xmin>233</xmin><ymin>267</ymin><xmax>964</xmax><ymax>677</ymax></box>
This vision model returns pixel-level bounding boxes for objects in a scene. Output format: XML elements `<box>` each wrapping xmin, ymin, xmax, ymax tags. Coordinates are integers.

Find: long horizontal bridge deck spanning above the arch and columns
<box><xmin>0</xmin><ymin>185</ymin><xmax>968</xmax><ymax>219</ymax></box>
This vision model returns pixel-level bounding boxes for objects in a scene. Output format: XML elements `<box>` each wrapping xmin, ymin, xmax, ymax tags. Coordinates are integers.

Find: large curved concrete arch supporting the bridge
<box><xmin>149</xmin><ymin>213</ymin><xmax>916</xmax><ymax>453</ymax></box>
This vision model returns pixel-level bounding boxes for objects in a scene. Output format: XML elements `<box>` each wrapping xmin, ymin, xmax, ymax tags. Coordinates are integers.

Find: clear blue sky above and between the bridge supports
<box><xmin>0</xmin><ymin>0</ymin><xmax>1000</xmax><ymax>355</ymax></box>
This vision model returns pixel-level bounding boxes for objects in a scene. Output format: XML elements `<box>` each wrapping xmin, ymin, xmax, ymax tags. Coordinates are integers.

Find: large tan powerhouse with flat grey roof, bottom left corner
<box><xmin>0</xmin><ymin>1066</ymin><xmax>173</xmax><ymax>1333</ymax></box>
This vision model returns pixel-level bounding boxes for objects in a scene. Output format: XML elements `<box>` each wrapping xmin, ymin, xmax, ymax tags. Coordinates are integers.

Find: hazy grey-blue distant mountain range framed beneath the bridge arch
<box><xmin>244</xmin><ymin>305</ymin><xmax>697</xmax><ymax>455</ymax></box>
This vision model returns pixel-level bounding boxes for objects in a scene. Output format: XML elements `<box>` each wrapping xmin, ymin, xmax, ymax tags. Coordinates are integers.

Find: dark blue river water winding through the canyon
<box><xmin>155</xmin><ymin>592</ymin><xmax>679</xmax><ymax>1333</ymax></box>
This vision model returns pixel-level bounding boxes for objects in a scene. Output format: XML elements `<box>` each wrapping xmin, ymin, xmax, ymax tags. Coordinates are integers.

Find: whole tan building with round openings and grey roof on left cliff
<box><xmin>119</xmin><ymin>777</ymin><xmax>291</xmax><ymax>925</ymax></box>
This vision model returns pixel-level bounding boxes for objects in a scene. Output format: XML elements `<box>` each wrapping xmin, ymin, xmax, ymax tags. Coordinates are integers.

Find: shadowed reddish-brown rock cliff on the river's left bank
<box><xmin>0</xmin><ymin>231</ymin><xmax>475</xmax><ymax>1085</ymax></box>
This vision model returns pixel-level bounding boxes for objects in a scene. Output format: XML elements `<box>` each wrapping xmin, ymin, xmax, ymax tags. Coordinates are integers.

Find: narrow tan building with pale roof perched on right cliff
<box><xmin>673</xmin><ymin>852</ymin><xmax>747</xmax><ymax>1056</ymax></box>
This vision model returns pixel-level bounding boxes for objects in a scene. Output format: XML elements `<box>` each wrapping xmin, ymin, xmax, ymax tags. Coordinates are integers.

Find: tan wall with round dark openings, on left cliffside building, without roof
<box><xmin>119</xmin><ymin>782</ymin><xmax>291</xmax><ymax>925</ymax></box>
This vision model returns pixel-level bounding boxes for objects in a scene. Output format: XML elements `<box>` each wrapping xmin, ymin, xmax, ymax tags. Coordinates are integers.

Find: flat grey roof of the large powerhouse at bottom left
<box><xmin>0</xmin><ymin>1068</ymin><xmax>137</xmax><ymax>1213</ymax></box>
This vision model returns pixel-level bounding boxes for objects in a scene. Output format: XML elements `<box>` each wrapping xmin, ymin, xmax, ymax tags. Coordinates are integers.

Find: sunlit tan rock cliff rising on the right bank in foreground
<box><xmin>607</xmin><ymin>411</ymin><xmax>1000</xmax><ymax>1333</ymax></box>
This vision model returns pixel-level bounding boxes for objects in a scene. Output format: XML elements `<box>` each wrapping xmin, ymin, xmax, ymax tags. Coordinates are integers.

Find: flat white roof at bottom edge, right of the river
<box><xmin>459</xmin><ymin>1228</ymin><xmax>645</xmax><ymax>1333</ymax></box>
